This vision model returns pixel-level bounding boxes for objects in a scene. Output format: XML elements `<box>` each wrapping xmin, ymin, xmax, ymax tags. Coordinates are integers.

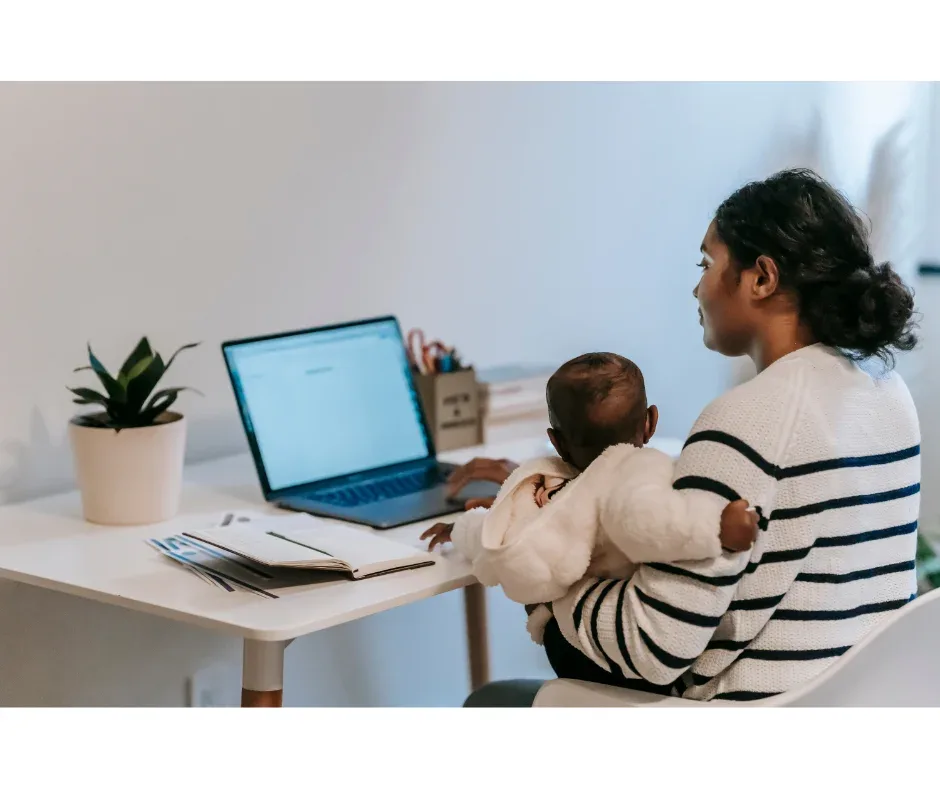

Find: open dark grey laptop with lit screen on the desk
<box><xmin>222</xmin><ymin>317</ymin><xmax>498</xmax><ymax>528</ymax></box>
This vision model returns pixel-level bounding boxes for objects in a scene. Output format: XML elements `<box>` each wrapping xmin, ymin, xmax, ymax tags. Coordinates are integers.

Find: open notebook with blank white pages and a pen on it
<box><xmin>184</xmin><ymin>515</ymin><xmax>434</xmax><ymax>580</ymax></box>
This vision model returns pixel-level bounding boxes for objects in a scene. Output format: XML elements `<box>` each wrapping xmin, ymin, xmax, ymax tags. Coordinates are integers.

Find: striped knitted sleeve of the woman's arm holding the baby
<box><xmin>552</xmin><ymin>369</ymin><xmax>803</xmax><ymax>685</ymax></box>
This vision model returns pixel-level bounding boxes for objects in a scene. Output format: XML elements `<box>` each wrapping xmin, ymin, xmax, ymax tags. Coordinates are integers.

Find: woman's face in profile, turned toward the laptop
<box><xmin>692</xmin><ymin>222</ymin><xmax>754</xmax><ymax>356</ymax></box>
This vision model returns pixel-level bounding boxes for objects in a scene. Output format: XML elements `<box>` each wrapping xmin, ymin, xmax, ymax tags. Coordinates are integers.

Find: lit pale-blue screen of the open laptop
<box><xmin>224</xmin><ymin>318</ymin><xmax>431</xmax><ymax>492</ymax></box>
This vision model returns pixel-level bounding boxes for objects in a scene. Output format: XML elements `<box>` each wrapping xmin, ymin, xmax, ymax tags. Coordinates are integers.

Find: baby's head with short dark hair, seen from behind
<box><xmin>545</xmin><ymin>353</ymin><xmax>659</xmax><ymax>471</ymax></box>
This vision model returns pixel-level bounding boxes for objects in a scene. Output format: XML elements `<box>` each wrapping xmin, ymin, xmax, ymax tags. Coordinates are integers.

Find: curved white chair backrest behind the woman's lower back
<box><xmin>776</xmin><ymin>589</ymin><xmax>940</xmax><ymax>707</ymax></box>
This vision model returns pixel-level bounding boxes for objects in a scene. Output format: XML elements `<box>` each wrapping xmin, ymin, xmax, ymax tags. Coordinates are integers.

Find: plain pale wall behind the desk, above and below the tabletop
<box><xmin>0</xmin><ymin>84</ymin><xmax>852</xmax><ymax>704</ymax></box>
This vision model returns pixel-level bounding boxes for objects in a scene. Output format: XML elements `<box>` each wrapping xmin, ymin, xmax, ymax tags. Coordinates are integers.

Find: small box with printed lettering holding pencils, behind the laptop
<box><xmin>415</xmin><ymin>368</ymin><xmax>483</xmax><ymax>451</ymax></box>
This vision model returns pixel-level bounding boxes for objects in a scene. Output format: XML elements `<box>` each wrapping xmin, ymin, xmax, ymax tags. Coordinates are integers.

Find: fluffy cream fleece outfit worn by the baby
<box><xmin>452</xmin><ymin>444</ymin><xmax>723</xmax><ymax>642</ymax></box>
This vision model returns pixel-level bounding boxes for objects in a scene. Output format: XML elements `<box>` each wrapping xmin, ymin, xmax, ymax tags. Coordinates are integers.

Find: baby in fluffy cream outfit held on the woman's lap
<box><xmin>422</xmin><ymin>353</ymin><xmax>758</xmax><ymax>642</ymax></box>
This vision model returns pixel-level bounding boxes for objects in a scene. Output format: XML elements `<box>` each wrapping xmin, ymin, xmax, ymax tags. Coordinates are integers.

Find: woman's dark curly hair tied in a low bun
<box><xmin>715</xmin><ymin>170</ymin><xmax>917</xmax><ymax>366</ymax></box>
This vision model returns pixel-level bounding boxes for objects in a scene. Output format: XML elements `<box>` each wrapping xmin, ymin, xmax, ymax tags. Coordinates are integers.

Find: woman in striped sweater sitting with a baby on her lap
<box><xmin>456</xmin><ymin>170</ymin><xmax>920</xmax><ymax>705</ymax></box>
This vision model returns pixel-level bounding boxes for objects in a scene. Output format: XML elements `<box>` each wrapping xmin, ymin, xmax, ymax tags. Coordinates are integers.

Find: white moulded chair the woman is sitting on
<box><xmin>534</xmin><ymin>589</ymin><xmax>940</xmax><ymax>708</ymax></box>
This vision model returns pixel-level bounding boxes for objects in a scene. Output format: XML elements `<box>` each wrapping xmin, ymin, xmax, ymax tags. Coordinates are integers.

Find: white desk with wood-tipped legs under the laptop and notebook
<box><xmin>0</xmin><ymin>431</ymin><xmax>676</xmax><ymax>705</ymax></box>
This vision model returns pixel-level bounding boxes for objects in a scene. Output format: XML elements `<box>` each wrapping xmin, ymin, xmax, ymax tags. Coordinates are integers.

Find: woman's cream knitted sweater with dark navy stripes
<box><xmin>553</xmin><ymin>345</ymin><xmax>920</xmax><ymax>700</ymax></box>
